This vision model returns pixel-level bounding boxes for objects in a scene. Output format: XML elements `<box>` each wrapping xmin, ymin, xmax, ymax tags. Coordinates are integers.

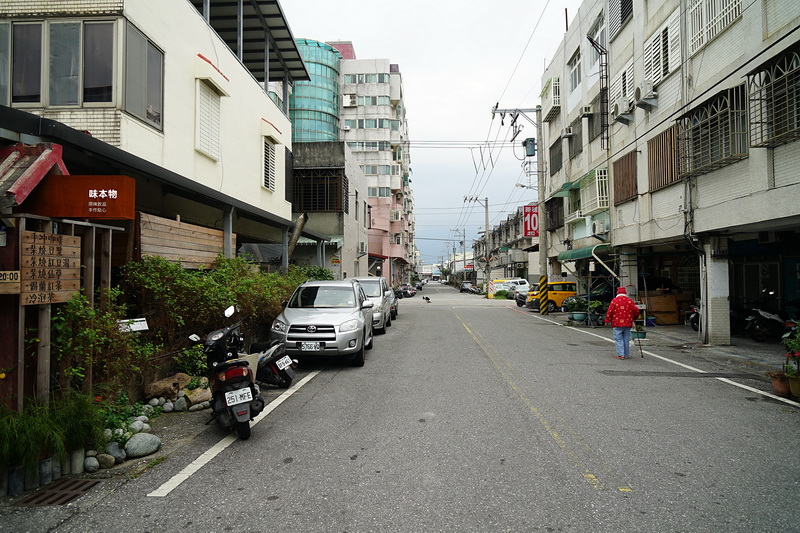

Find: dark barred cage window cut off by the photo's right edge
<box><xmin>747</xmin><ymin>46</ymin><xmax>800</xmax><ymax>147</ymax></box>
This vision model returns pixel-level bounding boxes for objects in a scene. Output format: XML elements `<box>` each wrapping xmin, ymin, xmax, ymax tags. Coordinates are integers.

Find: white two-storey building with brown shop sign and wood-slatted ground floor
<box><xmin>0</xmin><ymin>0</ymin><xmax>328</xmax><ymax>407</ymax></box>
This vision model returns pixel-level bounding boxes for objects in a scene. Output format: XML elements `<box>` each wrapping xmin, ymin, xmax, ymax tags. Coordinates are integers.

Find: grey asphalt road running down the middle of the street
<box><xmin>0</xmin><ymin>284</ymin><xmax>800</xmax><ymax>532</ymax></box>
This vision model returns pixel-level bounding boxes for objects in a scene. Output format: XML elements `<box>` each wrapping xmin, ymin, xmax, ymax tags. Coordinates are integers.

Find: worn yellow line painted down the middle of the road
<box><xmin>453</xmin><ymin>310</ymin><xmax>633</xmax><ymax>492</ymax></box>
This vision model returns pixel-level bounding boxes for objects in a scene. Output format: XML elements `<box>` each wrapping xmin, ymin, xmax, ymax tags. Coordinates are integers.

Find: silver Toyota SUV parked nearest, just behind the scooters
<box><xmin>270</xmin><ymin>280</ymin><xmax>375</xmax><ymax>366</ymax></box>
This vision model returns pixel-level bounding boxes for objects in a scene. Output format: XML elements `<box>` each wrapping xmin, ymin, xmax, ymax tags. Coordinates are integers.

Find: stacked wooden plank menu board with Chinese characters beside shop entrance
<box><xmin>20</xmin><ymin>231</ymin><xmax>81</xmax><ymax>305</ymax></box>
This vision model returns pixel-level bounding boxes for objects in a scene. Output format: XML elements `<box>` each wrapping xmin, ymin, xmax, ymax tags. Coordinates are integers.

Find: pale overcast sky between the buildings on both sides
<box><xmin>281</xmin><ymin>0</ymin><xmax>580</xmax><ymax>264</ymax></box>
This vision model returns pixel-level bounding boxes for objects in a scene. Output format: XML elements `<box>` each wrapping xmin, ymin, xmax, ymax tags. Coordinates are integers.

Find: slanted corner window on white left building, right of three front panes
<box><xmin>125</xmin><ymin>24</ymin><xmax>164</xmax><ymax>130</ymax></box>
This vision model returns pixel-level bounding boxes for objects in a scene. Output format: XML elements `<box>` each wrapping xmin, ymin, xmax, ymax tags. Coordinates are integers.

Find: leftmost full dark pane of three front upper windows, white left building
<box><xmin>11</xmin><ymin>24</ymin><xmax>42</xmax><ymax>103</ymax></box>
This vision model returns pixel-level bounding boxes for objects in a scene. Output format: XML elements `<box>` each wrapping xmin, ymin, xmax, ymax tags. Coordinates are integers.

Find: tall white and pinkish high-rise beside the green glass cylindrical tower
<box><xmin>328</xmin><ymin>42</ymin><xmax>417</xmax><ymax>285</ymax></box>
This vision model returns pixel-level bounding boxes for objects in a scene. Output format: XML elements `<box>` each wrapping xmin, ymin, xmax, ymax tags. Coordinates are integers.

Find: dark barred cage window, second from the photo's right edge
<box><xmin>678</xmin><ymin>85</ymin><xmax>750</xmax><ymax>177</ymax></box>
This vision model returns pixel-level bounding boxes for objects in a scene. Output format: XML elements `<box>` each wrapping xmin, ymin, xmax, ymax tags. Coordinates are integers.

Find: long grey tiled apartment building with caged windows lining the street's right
<box><xmin>539</xmin><ymin>0</ymin><xmax>800</xmax><ymax>344</ymax></box>
